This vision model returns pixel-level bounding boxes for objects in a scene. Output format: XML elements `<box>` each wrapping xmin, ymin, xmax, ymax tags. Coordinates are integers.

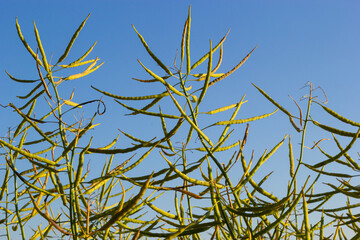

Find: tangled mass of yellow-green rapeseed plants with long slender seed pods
<box><xmin>0</xmin><ymin>8</ymin><xmax>360</xmax><ymax>240</ymax></box>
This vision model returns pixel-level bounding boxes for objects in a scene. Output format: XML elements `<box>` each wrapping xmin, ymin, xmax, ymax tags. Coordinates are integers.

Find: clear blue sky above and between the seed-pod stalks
<box><xmin>0</xmin><ymin>0</ymin><xmax>360</xmax><ymax>237</ymax></box>
